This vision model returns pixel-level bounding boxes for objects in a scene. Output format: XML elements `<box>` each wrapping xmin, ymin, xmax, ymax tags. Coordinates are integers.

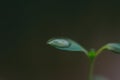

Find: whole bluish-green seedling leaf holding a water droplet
<box><xmin>47</xmin><ymin>38</ymin><xmax>88</xmax><ymax>54</ymax></box>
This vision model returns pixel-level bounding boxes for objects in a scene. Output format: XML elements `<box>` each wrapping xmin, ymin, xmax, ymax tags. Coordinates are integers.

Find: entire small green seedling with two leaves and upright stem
<box><xmin>47</xmin><ymin>38</ymin><xmax>120</xmax><ymax>80</ymax></box>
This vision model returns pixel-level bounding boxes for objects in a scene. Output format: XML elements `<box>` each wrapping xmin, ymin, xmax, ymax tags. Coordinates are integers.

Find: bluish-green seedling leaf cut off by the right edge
<box><xmin>106</xmin><ymin>43</ymin><xmax>120</xmax><ymax>54</ymax></box>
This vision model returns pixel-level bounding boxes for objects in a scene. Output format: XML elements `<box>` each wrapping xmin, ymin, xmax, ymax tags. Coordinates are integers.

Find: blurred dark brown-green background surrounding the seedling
<box><xmin>0</xmin><ymin>0</ymin><xmax>120</xmax><ymax>80</ymax></box>
